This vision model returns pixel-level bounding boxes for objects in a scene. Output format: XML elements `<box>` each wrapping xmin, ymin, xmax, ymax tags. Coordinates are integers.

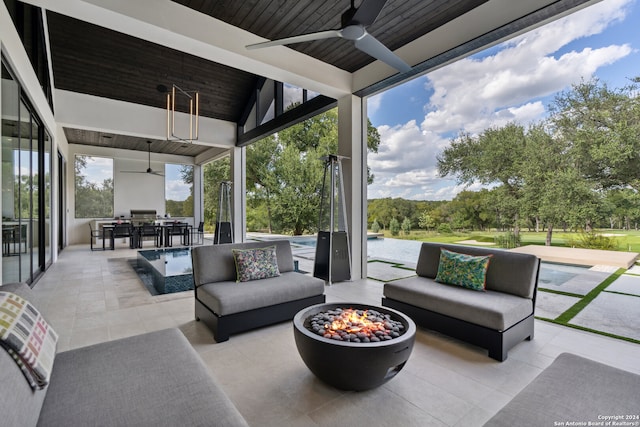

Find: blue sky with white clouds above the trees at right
<box><xmin>368</xmin><ymin>0</ymin><xmax>640</xmax><ymax>200</ymax></box>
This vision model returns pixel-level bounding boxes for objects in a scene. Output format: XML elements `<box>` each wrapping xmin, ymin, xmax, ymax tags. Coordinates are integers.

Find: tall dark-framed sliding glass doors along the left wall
<box><xmin>2</xmin><ymin>61</ymin><xmax>52</xmax><ymax>283</ymax></box>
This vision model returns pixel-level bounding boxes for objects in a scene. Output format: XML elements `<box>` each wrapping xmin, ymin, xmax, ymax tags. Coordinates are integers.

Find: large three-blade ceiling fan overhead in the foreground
<box><xmin>246</xmin><ymin>0</ymin><xmax>411</xmax><ymax>72</ymax></box>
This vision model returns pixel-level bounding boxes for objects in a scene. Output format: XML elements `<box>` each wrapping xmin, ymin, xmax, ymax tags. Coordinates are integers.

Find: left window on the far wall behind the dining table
<box><xmin>75</xmin><ymin>155</ymin><xmax>113</xmax><ymax>218</ymax></box>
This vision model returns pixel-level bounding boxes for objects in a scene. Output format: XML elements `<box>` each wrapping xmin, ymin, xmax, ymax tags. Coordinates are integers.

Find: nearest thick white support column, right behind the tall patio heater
<box><xmin>338</xmin><ymin>95</ymin><xmax>367</xmax><ymax>280</ymax></box>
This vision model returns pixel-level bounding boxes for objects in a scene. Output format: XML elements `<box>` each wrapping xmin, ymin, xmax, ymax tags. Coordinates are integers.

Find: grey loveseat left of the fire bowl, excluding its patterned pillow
<box><xmin>191</xmin><ymin>240</ymin><xmax>325</xmax><ymax>342</ymax></box>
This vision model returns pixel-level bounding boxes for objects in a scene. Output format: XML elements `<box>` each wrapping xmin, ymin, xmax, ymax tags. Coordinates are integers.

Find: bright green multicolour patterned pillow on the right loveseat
<box><xmin>436</xmin><ymin>248</ymin><xmax>491</xmax><ymax>291</ymax></box>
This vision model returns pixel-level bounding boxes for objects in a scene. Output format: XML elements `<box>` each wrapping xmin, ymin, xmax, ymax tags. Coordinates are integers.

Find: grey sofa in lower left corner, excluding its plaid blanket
<box><xmin>0</xmin><ymin>284</ymin><xmax>248</xmax><ymax>427</ymax></box>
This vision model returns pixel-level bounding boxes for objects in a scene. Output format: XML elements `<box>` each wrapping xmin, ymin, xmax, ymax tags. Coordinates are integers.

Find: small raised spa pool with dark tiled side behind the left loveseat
<box><xmin>138</xmin><ymin>248</ymin><xmax>193</xmax><ymax>294</ymax></box>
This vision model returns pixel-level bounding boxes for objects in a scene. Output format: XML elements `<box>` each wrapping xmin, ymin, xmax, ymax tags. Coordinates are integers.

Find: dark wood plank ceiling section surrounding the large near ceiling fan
<box><xmin>172</xmin><ymin>0</ymin><xmax>487</xmax><ymax>72</ymax></box>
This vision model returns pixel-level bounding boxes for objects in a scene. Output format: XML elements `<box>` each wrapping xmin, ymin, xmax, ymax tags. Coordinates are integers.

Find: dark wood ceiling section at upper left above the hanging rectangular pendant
<box><xmin>48</xmin><ymin>12</ymin><xmax>258</xmax><ymax>122</ymax></box>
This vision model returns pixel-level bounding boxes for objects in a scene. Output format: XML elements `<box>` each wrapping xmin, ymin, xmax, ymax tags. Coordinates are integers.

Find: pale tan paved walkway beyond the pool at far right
<box><xmin>511</xmin><ymin>245</ymin><xmax>640</xmax><ymax>269</ymax></box>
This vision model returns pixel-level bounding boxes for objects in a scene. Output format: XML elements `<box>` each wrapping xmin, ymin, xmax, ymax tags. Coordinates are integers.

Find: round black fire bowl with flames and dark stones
<box><xmin>293</xmin><ymin>303</ymin><xmax>416</xmax><ymax>391</ymax></box>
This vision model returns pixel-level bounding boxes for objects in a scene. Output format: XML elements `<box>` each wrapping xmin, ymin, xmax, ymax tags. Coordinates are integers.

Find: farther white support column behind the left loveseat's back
<box><xmin>230</xmin><ymin>147</ymin><xmax>247</xmax><ymax>242</ymax></box>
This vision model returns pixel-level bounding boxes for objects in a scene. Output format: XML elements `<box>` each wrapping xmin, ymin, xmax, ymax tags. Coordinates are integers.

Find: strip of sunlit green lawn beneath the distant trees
<box><xmin>381</xmin><ymin>230</ymin><xmax>640</xmax><ymax>252</ymax></box>
